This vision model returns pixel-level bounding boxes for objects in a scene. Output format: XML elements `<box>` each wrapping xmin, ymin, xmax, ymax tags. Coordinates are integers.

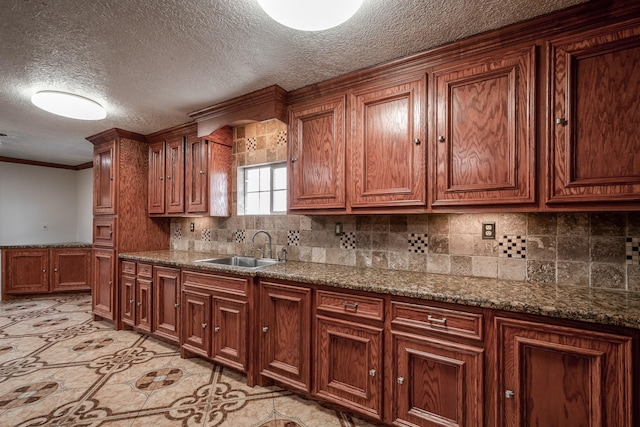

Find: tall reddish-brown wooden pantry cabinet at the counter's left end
<box><xmin>87</xmin><ymin>128</ymin><xmax>170</xmax><ymax>328</ymax></box>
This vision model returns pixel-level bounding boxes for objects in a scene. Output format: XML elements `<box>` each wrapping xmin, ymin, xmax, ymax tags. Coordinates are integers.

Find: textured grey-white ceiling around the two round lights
<box><xmin>0</xmin><ymin>0</ymin><xmax>584</xmax><ymax>167</ymax></box>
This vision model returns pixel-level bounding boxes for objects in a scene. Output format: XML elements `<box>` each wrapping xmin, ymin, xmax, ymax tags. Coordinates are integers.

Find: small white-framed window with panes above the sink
<box><xmin>238</xmin><ymin>163</ymin><xmax>287</xmax><ymax>215</ymax></box>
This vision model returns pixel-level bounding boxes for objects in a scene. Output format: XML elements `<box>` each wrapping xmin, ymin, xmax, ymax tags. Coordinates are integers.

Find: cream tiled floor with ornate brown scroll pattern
<box><xmin>0</xmin><ymin>295</ymin><xmax>370</xmax><ymax>427</ymax></box>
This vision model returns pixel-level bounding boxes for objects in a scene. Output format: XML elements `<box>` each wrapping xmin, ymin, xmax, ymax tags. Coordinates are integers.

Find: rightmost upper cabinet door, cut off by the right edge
<box><xmin>548</xmin><ymin>27</ymin><xmax>640</xmax><ymax>206</ymax></box>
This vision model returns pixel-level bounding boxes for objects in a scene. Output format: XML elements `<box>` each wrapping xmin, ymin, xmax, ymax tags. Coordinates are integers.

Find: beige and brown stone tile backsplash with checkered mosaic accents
<box><xmin>171</xmin><ymin>120</ymin><xmax>640</xmax><ymax>291</ymax></box>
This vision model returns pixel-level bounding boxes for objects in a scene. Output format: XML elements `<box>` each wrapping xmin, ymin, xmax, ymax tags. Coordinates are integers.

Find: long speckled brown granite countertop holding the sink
<box><xmin>120</xmin><ymin>250</ymin><xmax>640</xmax><ymax>329</ymax></box>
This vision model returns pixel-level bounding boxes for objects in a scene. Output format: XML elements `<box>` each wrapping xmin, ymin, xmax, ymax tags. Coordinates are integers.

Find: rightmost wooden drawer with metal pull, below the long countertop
<box><xmin>391</xmin><ymin>301</ymin><xmax>483</xmax><ymax>341</ymax></box>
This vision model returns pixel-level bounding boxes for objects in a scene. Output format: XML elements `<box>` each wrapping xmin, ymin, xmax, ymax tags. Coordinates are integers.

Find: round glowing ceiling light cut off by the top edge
<box><xmin>258</xmin><ymin>0</ymin><xmax>363</xmax><ymax>31</ymax></box>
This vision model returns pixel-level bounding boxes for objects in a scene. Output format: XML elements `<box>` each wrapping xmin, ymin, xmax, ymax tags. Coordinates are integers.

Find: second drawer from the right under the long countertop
<box><xmin>316</xmin><ymin>291</ymin><xmax>384</xmax><ymax>320</ymax></box>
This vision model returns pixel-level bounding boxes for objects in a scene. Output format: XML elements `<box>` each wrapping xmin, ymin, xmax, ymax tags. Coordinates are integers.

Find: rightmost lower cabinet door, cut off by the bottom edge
<box><xmin>496</xmin><ymin>318</ymin><xmax>633</xmax><ymax>427</ymax></box>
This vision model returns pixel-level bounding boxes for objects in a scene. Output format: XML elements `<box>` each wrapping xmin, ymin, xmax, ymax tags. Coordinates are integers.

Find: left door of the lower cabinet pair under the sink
<box><xmin>180</xmin><ymin>289</ymin><xmax>211</xmax><ymax>357</ymax></box>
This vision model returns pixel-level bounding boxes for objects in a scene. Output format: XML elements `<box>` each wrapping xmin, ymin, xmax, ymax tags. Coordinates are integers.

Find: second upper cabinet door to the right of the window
<box><xmin>350</xmin><ymin>76</ymin><xmax>427</xmax><ymax>208</ymax></box>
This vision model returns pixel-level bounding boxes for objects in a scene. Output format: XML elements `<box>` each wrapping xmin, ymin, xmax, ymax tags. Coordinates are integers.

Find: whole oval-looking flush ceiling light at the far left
<box><xmin>31</xmin><ymin>90</ymin><xmax>107</xmax><ymax>120</ymax></box>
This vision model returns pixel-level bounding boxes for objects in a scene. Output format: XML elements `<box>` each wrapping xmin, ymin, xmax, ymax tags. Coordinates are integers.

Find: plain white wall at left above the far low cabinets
<box><xmin>0</xmin><ymin>162</ymin><xmax>93</xmax><ymax>245</ymax></box>
